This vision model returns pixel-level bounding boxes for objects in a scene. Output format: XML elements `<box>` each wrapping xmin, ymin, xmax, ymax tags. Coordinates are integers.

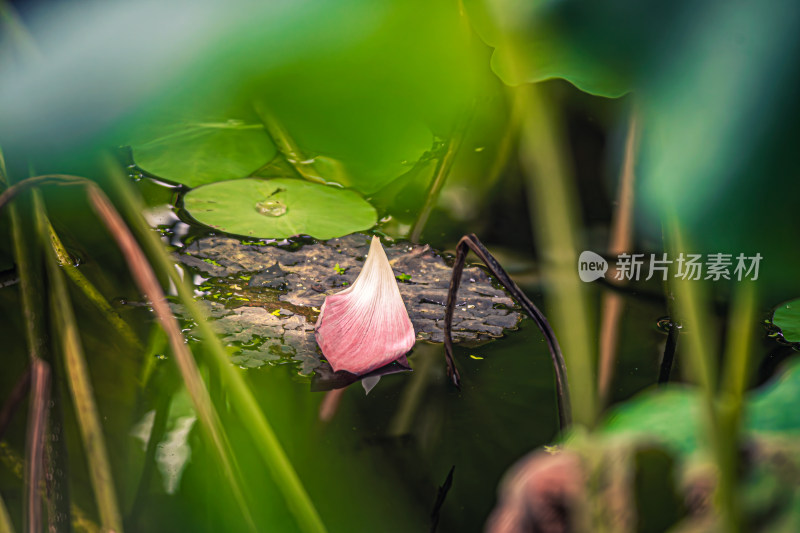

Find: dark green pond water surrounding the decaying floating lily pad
<box><xmin>0</xmin><ymin>167</ymin><xmax>666</xmax><ymax>532</ymax></box>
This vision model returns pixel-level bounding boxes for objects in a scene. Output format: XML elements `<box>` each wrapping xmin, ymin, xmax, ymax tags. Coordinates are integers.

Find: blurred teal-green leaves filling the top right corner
<box><xmin>466</xmin><ymin>0</ymin><xmax>800</xmax><ymax>295</ymax></box>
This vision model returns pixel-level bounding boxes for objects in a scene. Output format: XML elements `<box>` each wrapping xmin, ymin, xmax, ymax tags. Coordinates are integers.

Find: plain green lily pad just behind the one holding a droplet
<box><xmin>131</xmin><ymin>120</ymin><xmax>276</xmax><ymax>187</ymax></box>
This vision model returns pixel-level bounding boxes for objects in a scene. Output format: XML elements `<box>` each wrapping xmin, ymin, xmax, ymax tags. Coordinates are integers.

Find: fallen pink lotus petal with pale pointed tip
<box><xmin>315</xmin><ymin>237</ymin><xmax>415</xmax><ymax>375</ymax></box>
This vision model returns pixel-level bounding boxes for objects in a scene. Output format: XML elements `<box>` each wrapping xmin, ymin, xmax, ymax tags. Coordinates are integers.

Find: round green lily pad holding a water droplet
<box><xmin>183</xmin><ymin>178</ymin><xmax>378</xmax><ymax>239</ymax></box>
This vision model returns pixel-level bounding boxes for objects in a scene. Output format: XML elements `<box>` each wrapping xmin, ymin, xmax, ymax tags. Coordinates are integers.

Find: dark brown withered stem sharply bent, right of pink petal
<box><xmin>444</xmin><ymin>234</ymin><xmax>572</xmax><ymax>431</ymax></box>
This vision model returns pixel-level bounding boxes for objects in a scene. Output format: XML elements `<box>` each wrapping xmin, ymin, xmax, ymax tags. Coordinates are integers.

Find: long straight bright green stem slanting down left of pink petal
<box><xmin>105</xmin><ymin>156</ymin><xmax>326</xmax><ymax>533</ymax></box>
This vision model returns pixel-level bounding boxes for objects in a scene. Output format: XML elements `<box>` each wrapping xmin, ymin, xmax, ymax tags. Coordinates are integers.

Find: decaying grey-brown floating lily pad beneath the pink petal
<box><xmin>175</xmin><ymin>234</ymin><xmax>522</xmax><ymax>374</ymax></box>
